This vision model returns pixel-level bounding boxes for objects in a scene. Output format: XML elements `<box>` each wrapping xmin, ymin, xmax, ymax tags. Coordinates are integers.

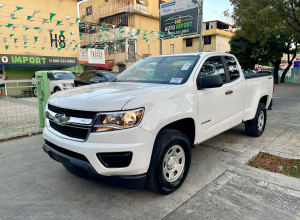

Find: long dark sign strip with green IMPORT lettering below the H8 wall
<box><xmin>0</xmin><ymin>54</ymin><xmax>77</xmax><ymax>66</ymax></box>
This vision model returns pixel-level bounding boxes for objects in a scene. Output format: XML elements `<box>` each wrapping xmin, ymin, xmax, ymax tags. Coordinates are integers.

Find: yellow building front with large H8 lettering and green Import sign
<box><xmin>0</xmin><ymin>0</ymin><xmax>83</xmax><ymax>80</ymax></box>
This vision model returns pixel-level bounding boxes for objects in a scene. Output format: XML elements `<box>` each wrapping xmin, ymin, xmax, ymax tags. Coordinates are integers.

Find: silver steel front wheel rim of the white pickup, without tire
<box><xmin>163</xmin><ymin>145</ymin><xmax>185</xmax><ymax>183</ymax></box>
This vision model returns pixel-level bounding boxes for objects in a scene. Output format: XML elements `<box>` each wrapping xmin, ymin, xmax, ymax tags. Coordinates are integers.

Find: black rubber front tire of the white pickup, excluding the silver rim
<box><xmin>146</xmin><ymin>129</ymin><xmax>192</xmax><ymax>195</ymax></box>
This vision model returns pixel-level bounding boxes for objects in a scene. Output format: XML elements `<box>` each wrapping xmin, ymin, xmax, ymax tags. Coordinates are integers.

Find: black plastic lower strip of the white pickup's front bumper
<box><xmin>43</xmin><ymin>143</ymin><xmax>147</xmax><ymax>190</ymax></box>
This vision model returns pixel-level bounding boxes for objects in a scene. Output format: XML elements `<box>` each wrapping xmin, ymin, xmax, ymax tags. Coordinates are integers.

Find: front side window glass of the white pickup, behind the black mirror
<box><xmin>200</xmin><ymin>56</ymin><xmax>227</xmax><ymax>83</ymax></box>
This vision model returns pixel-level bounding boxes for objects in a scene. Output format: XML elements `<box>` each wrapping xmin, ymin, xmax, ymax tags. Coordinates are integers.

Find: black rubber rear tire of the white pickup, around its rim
<box><xmin>245</xmin><ymin>103</ymin><xmax>267</xmax><ymax>137</ymax></box>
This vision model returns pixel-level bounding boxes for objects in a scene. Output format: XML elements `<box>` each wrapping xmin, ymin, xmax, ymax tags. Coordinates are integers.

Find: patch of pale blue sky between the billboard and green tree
<box><xmin>203</xmin><ymin>0</ymin><xmax>233</xmax><ymax>24</ymax></box>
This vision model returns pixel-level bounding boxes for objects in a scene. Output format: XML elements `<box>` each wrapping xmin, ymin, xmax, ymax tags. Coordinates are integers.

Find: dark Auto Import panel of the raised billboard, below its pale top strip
<box><xmin>160</xmin><ymin>8</ymin><xmax>198</xmax><ymax>38</ymax></box>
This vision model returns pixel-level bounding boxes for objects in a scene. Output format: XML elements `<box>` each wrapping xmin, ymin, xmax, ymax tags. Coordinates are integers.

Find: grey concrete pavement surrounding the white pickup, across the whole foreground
<box><xmin>0</xmin><ymin>84</ymin><xmax>300</xmax><ymax>219</ymax></box>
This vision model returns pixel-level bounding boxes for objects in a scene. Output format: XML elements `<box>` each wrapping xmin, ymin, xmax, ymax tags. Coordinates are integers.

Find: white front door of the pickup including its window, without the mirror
<box><xmin>198</xmin><ymin>56</ymin><xmax>233</xmax><ymax>140</ymax></box>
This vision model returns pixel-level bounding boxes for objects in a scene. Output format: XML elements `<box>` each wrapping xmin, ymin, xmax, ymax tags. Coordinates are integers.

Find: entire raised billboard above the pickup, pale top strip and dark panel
<box><xmin>160</xmin><ymin>0</ymin><xmax>199</xmax><ymax>38</ymax></box>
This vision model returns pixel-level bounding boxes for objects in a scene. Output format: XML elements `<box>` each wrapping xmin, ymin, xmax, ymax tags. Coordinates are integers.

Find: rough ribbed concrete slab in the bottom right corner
<box><xmin>165</xmin><ymin>172</ymin><xmax>300</xmax><ymax>220</ymax></box>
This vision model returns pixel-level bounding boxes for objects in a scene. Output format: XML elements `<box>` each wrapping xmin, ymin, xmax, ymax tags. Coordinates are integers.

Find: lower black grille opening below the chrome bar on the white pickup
<box><xmin>49</xmin><ymin>121</ymin><xmax>89</xmax><ymax>140</ymax></box>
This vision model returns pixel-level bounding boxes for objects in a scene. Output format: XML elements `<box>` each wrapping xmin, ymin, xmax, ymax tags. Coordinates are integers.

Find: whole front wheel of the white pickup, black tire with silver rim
<box><xmin>146</xmin><ymin>129</ymin><xmax>192</xmax><ymax>195</ymax></box>
